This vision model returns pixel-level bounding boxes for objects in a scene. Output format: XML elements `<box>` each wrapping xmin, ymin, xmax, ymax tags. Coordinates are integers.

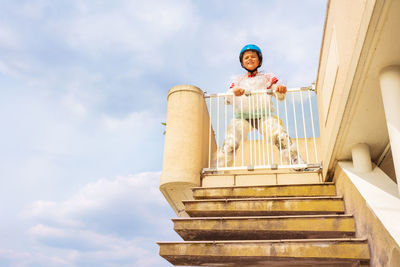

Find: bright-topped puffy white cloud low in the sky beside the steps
<box><xmin>24</xmin><ymin>173</ymin><xmax>169</xmax><ymax>236</ymax></box>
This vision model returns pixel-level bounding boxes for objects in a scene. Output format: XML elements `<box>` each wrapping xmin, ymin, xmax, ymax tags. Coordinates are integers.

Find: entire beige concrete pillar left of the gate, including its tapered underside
<box><xmin>160</xmin><ymin>85</ymin><xmax>216</xmax><ymax>216</ymax></box>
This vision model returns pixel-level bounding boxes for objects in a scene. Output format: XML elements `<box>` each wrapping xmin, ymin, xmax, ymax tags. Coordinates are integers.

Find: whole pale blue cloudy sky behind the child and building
<box><xmin>0</xmin><ymin>0</ymin><xmax>326</xmax><ymax>267</ymax></box>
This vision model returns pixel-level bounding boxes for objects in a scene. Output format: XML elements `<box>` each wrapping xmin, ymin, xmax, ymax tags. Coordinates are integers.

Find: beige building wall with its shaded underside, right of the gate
<box><xmin>316</xmin><ymin>0</ymin><xmax>400</xmax><ymax>182</ymax></box>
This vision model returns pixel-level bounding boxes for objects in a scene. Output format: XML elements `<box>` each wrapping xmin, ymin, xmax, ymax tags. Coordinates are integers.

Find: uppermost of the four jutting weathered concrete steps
<box><xmin>192</xmin><ymin>183</ymin><xmax>336</xmax><ymax>199</ymax></box>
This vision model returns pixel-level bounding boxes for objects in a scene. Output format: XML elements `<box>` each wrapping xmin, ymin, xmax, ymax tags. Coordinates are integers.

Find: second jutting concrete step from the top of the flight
<box><xmin>182</xmin><ymin>197</ymin><xmax>344</xmax><ymax>217</ymax></box>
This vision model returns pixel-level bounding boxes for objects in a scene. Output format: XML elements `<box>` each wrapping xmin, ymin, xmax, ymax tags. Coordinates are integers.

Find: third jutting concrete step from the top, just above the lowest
<box><xmin>172</xmin><ymin>215</ymin><xmax>355</xmax><ymax>241</ymax></box>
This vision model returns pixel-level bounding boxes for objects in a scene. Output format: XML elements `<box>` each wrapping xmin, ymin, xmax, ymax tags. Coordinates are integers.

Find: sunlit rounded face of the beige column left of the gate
<box><xmin>161</xmin><ymin>85</ymin><xmax>204</xmax><ymax>186</ymax></box>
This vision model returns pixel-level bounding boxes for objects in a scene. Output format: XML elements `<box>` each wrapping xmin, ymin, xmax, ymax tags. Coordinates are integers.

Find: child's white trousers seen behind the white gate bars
<box><xmin>214</xmin><ymin>116</ymin><xmax>304</xmax><ymax>167</ymax></box>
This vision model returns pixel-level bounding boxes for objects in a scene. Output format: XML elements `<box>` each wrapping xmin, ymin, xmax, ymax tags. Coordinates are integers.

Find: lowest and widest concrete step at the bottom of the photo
<box><xmin>158</xmin><ymin>238</ymin><xmax>370</xmax><ymax>266</ymax></box>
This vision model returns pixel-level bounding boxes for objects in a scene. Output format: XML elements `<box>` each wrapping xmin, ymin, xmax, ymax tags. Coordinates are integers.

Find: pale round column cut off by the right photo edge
<box><xmin>379</xmin><ymin>65</ymin><xmax>400</xmax><ymax>191</ymax></box>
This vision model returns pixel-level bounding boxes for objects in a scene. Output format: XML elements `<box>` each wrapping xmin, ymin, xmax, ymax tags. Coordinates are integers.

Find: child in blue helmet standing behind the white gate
<box><xmin>217</xmin><ymin>44</ymin><xmax>305</xmax><ymax>170</ymax></box>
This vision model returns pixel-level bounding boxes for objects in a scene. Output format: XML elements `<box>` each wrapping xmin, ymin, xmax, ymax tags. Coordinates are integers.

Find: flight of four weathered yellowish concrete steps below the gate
<box><xmin>158</xmin><ymin>178</ymin><xmax>370</xmax><ymax>266</ymax></box>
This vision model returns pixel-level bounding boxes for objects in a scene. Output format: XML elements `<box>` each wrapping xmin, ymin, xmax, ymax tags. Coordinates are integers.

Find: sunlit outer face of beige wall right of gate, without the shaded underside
<box><xmin>316</xmin><ymin>0</ymin><xmax>368</xmax><ymax>180</ymax></box>
